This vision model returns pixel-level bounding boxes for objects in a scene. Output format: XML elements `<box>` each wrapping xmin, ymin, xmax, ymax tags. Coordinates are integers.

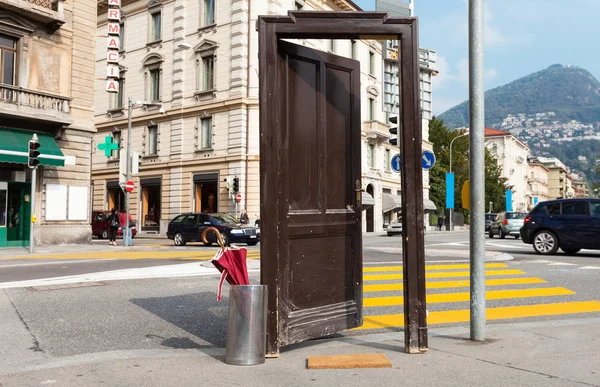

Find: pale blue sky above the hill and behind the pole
<box><xmin>353</xmin><ymin>0</ymin><xmax>600</xmax><ymax>115</ymax></box>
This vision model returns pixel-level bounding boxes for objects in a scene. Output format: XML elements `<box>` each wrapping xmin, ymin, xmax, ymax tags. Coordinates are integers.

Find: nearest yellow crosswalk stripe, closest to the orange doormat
<box><xmin>355</xmin><ymin>301</ymin><xmax>600</xmax><ymax>330</ymax></box>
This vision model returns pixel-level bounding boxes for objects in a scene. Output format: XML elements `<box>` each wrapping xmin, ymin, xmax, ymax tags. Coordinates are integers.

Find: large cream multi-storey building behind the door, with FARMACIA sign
<box><xmin>92</xmin><ymin>0</ymin><xmax>436</xmax><ymax>234</ymax></box>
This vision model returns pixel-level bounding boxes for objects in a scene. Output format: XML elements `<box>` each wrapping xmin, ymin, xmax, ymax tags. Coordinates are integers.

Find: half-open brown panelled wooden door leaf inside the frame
<box><xmin>261</xmin><ymin>41</ymin><xmax>362</xmax><ymax>353</ymax></box>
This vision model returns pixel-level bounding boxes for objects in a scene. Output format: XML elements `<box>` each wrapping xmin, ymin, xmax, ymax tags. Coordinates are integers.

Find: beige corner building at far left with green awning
<box><xmin>0</xmin><ymin>0</ymin><xmax>96</xmax><ymax>247</ymax></box>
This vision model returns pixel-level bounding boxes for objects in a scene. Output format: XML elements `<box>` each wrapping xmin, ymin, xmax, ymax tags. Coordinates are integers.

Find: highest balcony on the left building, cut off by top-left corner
<box><xmin>0</xmin><ymin>0</ymin><xmax>65</xmax><ymax>33</ymax></box>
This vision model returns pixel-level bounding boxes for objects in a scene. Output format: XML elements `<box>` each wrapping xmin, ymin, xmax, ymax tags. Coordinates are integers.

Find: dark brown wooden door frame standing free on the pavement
<box><xmin>257</xmin><ymin>11</ymin><xmax>427</xmax><ymax>356</ymax></box>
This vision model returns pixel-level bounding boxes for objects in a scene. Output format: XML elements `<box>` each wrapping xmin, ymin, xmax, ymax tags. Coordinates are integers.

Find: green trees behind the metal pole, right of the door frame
<box><xmin>429</xmin><ymin>117</ymin><xmax>507</xmax><ymax>219</ymax></box>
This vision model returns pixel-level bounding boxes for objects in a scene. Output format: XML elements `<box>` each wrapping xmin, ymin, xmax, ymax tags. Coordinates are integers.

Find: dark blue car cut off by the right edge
<box><xmin>521</xmin><ymin>198</ymin><xmax>600</xmax><ymax>255</ymax></box>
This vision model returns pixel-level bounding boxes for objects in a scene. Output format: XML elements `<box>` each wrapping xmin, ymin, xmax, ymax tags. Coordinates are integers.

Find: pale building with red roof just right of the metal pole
<box><xmin>485</xmin><ymin>128</ymin><xmax>530</xmax><ymax>211</ymax></box>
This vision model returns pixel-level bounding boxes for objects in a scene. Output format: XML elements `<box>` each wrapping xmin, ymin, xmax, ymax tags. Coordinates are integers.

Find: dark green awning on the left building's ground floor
<box><xmin>0</xmin><ymin>128</ymin><xmax>65</xmax><ymax>167</ymax></box>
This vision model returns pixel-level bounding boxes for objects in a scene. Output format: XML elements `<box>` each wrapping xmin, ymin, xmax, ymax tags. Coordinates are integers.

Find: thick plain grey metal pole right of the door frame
<box><xmin>469</xmin><ymin>0</ymin><xmax>485</xmax><ymax>341</ymax></box>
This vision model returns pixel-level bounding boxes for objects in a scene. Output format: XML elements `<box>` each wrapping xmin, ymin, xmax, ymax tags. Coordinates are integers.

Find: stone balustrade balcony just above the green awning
<box><xmin>0</xmin><ymin>84</ymin><xmax>72</xmax><ymax>125</ymax></box>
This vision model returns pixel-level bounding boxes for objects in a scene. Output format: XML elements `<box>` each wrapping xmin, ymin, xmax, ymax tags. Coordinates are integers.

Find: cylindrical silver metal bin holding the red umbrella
<box><xmin>225</xmin><ymin>285</ymin><xmax>267</xmax><ymax>365</ymax></box>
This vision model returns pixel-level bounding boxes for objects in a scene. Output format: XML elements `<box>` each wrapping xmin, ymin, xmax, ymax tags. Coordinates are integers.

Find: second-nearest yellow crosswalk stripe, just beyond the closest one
<box><xmin>363</xmin><ymin>287</ymin><xmax>577</xmax><ymax>307</ymax></box>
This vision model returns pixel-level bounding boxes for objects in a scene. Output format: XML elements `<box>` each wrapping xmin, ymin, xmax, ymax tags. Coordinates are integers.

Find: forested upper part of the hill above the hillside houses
<box><xmin>438</xmin><ymin>64</ymin><xmax>600</xmax><ymax>128</ymax></box>
